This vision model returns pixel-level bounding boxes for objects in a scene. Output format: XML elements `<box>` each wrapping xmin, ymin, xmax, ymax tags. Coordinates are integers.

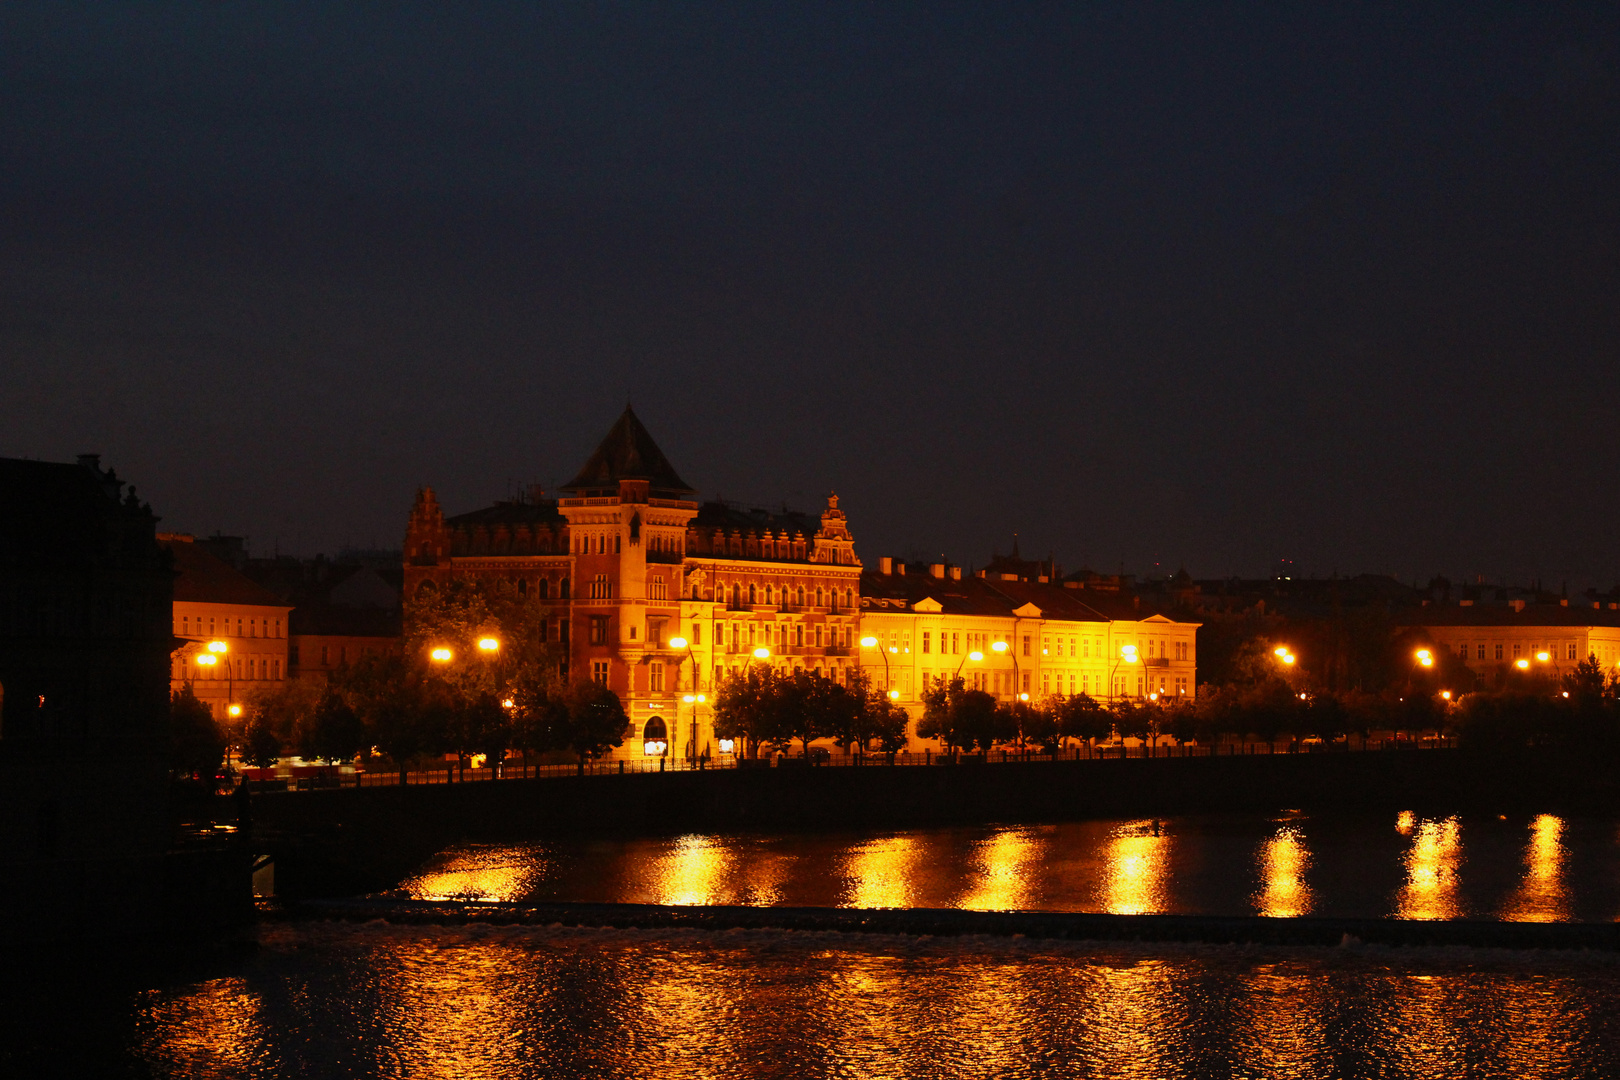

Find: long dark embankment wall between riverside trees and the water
<box><xmin>253</xmin><ymin>750</ymin><xmax>1620</xmax><ymax>899</ymax></box>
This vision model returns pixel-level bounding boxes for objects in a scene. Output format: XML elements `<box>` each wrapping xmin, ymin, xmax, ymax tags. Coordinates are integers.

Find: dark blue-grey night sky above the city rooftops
<box><xmin>0</xmin><ymin>0</ymin><xmax>1620</xmax><ymax>588</ymax></box>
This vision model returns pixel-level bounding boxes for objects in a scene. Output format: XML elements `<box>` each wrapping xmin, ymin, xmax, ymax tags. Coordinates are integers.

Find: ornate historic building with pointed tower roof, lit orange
<box><xmin>405</xmin><ymin>408</ymin><xmax>860</xmax><ymax>756</ymax></box>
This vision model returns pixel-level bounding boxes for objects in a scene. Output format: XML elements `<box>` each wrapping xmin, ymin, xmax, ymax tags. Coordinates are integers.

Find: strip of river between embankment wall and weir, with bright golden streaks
<box><xmin>402</xmin><ymin>813</ymin><xmax>1620</xmax><ymax>921</ymax></box>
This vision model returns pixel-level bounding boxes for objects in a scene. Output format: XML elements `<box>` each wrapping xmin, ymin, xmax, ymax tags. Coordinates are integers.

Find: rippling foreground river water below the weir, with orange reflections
<box><xmin>19</xmin><ymin>923</ymin><xmax>1620</xmax><ymax>1078</ymax></box>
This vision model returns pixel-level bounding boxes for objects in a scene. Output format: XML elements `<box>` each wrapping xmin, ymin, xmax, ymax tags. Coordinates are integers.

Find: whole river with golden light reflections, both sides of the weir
<box><xmin>19</xmin><ymin>816</ymin><xmax>1620</xmax><ymax>1080</ymax></box>
